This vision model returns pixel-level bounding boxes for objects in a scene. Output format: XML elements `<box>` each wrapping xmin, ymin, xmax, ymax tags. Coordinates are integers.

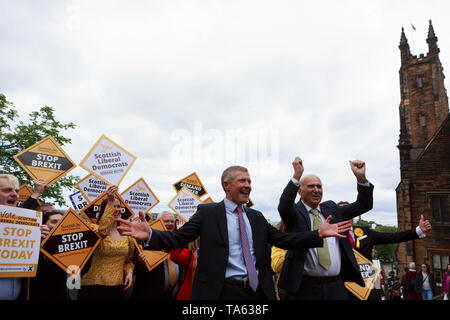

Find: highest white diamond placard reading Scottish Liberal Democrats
<box><xmin>80</xmin><ymin>135</ymin><xmax>136</xmax><ymax>185</ymax></box>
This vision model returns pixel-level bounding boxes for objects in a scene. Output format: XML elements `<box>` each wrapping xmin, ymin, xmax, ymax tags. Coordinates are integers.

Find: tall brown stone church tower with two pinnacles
<box><xmin>396</xmin><ymin>20</ymin><xmax>450</xmax><ymax>276</ymax></box>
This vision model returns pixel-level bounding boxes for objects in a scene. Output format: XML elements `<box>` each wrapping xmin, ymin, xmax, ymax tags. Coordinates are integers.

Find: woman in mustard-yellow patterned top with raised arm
<box><xmin>79</xmin><ymin>186</ymin><xmax>134</xmax><ymax>300</ymax></box>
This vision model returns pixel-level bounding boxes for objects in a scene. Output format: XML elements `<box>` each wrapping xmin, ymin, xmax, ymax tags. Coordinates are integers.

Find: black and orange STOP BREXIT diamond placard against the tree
<box><xmin>14</xmin><ymin>136</ymin><xmax>76</xmax><ymax>185</ymax></box>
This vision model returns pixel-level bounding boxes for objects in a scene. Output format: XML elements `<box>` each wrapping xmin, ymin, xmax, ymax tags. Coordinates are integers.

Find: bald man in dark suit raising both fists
<box><xmin>278</xmin><ymin>157</ymin><xmax>373</xmax><ymax>300</ymax></box>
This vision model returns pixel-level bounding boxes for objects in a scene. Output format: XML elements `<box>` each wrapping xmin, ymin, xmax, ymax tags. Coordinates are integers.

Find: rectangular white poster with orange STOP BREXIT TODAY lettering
<box><xmin>0</xmin><ymin>205</ymin><xmax>42</xmax><ymax>278</ymax></box>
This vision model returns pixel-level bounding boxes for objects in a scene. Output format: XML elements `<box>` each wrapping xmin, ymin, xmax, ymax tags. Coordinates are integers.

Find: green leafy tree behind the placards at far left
<box><xmin>0</xmin><ymin>93</ymin><xmax>80</xmax><ymax>206</ymax></box>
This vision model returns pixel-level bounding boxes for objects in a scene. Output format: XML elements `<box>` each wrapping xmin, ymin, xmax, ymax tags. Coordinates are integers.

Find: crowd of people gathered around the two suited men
<box><xmin>0</xmin><ymin>157</ymin><xmax>450</xmax><ymax>300</ymax></box>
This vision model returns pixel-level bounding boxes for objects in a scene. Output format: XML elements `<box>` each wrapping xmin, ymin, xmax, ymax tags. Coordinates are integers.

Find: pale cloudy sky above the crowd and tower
<box><xmin>0</xmin><ymin>0</ymin><xmax>450</xmax><ymax>225</ymax></box>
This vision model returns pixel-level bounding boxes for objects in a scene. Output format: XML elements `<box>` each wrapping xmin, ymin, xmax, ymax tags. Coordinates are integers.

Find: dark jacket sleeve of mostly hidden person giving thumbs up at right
<box><xmin>353</xmin><ymin>226</ymin><xmax>419</xmax><ymax>261</ymax></box>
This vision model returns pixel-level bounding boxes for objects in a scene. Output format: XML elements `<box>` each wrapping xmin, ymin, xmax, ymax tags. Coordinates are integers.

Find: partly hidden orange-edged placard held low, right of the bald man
<box><xmin>345</xmin><ymin>249</ymin><xmax>380</xmax><ymax>300</ymax></box>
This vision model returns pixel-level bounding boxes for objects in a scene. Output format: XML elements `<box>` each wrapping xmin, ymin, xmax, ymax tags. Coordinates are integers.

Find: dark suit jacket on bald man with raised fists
<box><xmin>278</xmin><ymin>180</ymin><xmax>373</xmax><ymax>293</ymax></box>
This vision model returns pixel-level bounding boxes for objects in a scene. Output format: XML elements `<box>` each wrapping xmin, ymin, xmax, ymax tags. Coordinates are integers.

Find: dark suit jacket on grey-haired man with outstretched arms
<box><xmin>147</xmin><ymin>201</ymin><xmax>323</xmax><ymax>300</ymax></box>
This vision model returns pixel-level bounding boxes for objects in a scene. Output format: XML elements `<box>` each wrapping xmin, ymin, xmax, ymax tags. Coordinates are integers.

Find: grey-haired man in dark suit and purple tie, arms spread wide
<box><xmin>118</xmin><ymin>166</ymin><xmax>349</xmax><ymax>300</ymax></box>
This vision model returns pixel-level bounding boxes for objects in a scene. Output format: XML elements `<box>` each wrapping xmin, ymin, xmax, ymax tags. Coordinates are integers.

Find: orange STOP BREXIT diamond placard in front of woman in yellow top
<box><xmin>41</xmin><ymin>209</ymin><xmax>100</xmax><ymax>278</ymax></box>
